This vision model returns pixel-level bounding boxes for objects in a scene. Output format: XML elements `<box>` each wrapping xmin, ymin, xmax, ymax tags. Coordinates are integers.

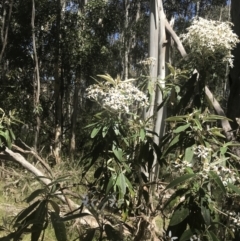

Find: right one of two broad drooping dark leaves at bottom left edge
<box><xmin>50</xmin><ymin>212</ymin><xmax>67</xmax><ymax>241</ymax></box>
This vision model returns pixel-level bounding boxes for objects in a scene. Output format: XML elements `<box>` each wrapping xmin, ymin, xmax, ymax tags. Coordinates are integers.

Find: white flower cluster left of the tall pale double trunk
<box><xmin>86</xmin><ymin>81</ymin><xmax>149</xmax><ymax>113</ymax></box>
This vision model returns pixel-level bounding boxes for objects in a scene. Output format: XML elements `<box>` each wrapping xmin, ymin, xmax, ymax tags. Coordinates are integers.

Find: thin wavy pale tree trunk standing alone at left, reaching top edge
<box><xmin>31</xmin><ymin>0</ymin><xmax>41</xmax><ymax>151</ymax></box>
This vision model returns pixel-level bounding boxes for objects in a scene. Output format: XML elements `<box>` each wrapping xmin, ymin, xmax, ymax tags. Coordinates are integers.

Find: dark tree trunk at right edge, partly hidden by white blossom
<box><xmin>227</xmin><ymin>0</ymin><xmax>240</xmax><ymax>129</ymax></box>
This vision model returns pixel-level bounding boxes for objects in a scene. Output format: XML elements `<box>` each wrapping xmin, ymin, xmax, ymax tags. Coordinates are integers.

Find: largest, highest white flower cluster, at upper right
<box><xmin>180</xmin><ymin>18</ymin><xmax>240</xmax><ymax>67</ymax></box>
